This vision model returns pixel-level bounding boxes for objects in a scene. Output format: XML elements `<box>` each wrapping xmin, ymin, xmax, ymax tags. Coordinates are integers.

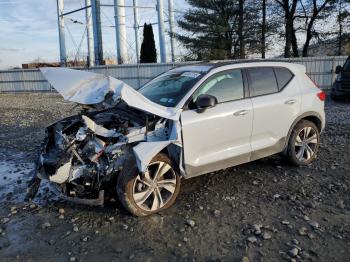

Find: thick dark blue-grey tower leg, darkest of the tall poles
<box><xmin>91</xmin><ymin>0</ymin><xmax>103</xmax><ymax>65</ymax></box>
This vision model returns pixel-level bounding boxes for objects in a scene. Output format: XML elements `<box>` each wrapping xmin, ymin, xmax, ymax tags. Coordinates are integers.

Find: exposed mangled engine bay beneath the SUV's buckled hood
<box><xmin>27</xmin><ymin>105</ymin><xmax>175</xmax><ymax>206</ymax></box>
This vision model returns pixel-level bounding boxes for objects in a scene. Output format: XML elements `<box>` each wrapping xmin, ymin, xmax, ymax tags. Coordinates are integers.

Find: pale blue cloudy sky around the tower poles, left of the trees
<box><xmin>0</xmin><ymin>0</ymin><xmax>188</xmax><ymax>69</ymax></box>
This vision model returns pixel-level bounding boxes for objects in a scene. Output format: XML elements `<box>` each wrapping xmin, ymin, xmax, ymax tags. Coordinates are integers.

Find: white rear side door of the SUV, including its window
<box><xmin>246</xmin><ymin>67</ymin><xmax>301</xmax><ymax>160</ymax></box>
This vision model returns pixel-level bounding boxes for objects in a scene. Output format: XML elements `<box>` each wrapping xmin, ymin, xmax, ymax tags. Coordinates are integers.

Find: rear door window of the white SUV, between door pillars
<box><xmin>248</xmin><ymin>67</ymin><xmax>278</xmax><ymax>96</ymax></box>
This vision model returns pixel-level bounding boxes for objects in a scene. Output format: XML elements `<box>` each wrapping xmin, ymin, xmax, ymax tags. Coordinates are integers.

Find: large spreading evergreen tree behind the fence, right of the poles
<box><xmin>175</xmin><ymin>0</ymin><xmax>238</xmax><ymax>60</ymax></box>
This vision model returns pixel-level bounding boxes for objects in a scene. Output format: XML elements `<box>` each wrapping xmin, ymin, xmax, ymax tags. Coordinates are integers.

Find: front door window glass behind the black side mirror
<box><xmin>193</xmin><ymin>70</ymin><xmax>244</xmax><ymax>103</ymax></box>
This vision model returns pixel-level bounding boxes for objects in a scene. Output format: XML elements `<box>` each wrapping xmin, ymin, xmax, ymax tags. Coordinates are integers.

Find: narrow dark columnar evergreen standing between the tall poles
<box><xmin>140</xmin><ymin>23</ymin><xmax>157</xmax><ymax>63</ymax></box>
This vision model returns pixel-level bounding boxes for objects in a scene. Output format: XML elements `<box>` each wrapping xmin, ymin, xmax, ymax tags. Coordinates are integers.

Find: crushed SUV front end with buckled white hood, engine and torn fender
<box><xmin>26</xmin><ymin>68</ymin><xmax>182</xmax><ymax>205</ymax></box>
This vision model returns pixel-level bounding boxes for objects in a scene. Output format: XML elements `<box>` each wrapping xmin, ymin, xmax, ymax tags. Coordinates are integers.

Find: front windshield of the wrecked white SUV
<box><xmin>139</xmin><ymin>71</ymin><xmax>205</xmax><ymax>107</ymax></box>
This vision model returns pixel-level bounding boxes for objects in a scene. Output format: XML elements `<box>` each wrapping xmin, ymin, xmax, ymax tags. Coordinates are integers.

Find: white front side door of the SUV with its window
<box><xmin>181</xmin><ymin>69</ymin><xmax>253</xmax><ymax>177</ymax></box>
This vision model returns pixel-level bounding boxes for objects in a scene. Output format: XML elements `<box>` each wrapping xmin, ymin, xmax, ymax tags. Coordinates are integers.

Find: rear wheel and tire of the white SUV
<box><xmin>287</xmin><ymin>120</ymin><xmax>320</xmax><ymax>166</ymax></box>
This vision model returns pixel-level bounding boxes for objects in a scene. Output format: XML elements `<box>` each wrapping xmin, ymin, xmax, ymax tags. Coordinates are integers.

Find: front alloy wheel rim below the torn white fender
<box><xmin>133</xmin><ymin>161</ymin><xmax>177</xmax><ymax>211</ymax></box>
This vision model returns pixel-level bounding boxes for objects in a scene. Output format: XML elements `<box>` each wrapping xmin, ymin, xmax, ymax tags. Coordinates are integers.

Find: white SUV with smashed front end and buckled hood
<box><xmin>27</xmin><ymin>62</ymin><xmax>325</xmax><ymax>216</ymax></box>
